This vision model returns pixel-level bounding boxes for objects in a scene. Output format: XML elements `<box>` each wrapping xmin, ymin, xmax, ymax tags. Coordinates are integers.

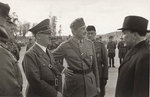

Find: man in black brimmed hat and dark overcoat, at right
<box><xmin>115</xmin><ymin>16</ymin><xmax>150</xmax><ymax>97</ymax></box>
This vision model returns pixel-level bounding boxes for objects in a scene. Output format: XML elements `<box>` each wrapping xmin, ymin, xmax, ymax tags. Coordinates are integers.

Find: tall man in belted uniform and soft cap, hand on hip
<box><xmin>53</xmin><ymin>18</ymin><xmax>99</xmax><ymax>97</ymax></box>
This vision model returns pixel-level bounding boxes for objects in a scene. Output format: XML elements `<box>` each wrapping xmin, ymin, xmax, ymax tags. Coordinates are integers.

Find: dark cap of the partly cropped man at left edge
<box><xmin>0</xmin><ymin>2</ymin><xmax>10</xmax><ymax>18</ymax></box>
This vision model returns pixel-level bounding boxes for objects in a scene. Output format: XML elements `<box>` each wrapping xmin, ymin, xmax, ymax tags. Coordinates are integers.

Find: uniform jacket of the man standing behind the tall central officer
<box><xmin>93</xmin><ymin>40</ymin><xmax>108</xmax><ymax>79</ymax></box>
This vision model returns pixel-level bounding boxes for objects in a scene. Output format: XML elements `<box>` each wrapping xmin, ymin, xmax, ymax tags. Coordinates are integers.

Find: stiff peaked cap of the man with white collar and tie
<box><xmin>29</xmin><ymin>19</ymin><xmax>52</xmax><ymax>35</ymax></box>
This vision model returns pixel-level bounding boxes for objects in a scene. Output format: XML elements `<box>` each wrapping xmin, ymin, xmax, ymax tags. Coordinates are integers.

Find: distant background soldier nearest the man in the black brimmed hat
<box><xmin>118</xmin><ymin>37</ymin><xmax>128</xmax><ymax>64</ymax></box>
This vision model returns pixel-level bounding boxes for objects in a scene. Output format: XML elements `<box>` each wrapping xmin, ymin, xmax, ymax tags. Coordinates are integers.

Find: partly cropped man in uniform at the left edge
<box><xmin>0</xmin><ymin>2</ymin><xmax>22</xmax><ymax>97</ymax></box>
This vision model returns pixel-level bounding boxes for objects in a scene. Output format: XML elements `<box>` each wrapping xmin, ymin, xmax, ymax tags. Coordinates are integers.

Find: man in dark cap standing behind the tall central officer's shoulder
<box><xmin>86</xmin><ymin>25</ymin><xmax>108</xmax><ymax>97</ymax></box>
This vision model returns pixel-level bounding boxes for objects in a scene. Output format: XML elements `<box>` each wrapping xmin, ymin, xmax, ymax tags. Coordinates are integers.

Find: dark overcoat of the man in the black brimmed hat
<box><xmin>115</xmin><ymin>41</ymin><xmax>150</xmax><ymax>97</ymax></box>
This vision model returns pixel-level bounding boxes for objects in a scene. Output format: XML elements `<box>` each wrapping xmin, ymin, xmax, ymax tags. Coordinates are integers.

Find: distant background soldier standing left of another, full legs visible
<box><xmin>107</xmin><ymin>36</ymin><xmax>116</xmax><ymax>67</ymax></box>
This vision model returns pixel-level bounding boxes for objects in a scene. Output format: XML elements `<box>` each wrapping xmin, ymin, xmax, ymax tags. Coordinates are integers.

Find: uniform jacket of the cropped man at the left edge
<box><xmin>0</xmin><ymin>46</ymin><xmax>22</xmax><ymax>97</ymax></box>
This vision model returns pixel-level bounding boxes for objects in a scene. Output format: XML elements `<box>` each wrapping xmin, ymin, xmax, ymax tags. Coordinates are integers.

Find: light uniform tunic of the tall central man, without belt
<box><xmin>53</xmin><ymin>37</ymin><xmax>99</xmax><ymax>97</ymax></box>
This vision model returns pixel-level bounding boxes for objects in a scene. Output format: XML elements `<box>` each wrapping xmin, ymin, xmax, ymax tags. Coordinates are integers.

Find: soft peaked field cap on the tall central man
<box><xmin>70</xmin><ymin>18</ymin><xmax>85</xmax><ymax>29</ymax></box>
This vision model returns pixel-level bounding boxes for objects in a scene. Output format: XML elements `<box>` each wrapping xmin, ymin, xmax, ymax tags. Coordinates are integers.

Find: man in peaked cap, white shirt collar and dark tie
<box><xmin>22</xmin><ymin>19</ymin><xmax>62</xmax><ymax>97</ymax></box>
